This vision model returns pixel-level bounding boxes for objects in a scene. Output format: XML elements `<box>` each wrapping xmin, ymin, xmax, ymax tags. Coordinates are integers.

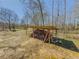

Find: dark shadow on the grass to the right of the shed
<box><xmin>50</xmin><ymin>37</ymin><xmax>79</xmax><ymax>52</ymax></box>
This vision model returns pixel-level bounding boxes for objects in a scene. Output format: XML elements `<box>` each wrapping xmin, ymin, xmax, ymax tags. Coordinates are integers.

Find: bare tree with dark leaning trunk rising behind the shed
<box><xmin>23</xmin><ymin>0</ymin><xmax>45</xmax><ymax>25</ymax></box>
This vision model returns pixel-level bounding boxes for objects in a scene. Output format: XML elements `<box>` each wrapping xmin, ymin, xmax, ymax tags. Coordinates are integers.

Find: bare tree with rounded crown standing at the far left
<box><xmin>0</xmin><ymin>8</ymin><xmax>18</xmax><ymax>31</ymax></box>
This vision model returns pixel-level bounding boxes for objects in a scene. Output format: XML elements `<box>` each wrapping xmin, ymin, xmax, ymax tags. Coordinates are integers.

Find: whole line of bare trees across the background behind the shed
<box><xmin>0</xmin><ymin>0</ymin><xmax>79</xmax><ymax>31</ymax></box>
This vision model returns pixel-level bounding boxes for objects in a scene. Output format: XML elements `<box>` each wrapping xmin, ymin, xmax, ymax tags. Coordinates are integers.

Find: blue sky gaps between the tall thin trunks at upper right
<box><xmin>45</xmin><ymin>0</ymin><xmax>74</xmax><ymax>14</ymax></box>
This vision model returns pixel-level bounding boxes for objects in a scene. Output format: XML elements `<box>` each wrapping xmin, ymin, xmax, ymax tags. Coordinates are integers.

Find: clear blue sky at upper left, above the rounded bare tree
<box><xmin>0</xmin><ymin>0</ymin><xmax>24</xmax><ymax>17</ymax></box>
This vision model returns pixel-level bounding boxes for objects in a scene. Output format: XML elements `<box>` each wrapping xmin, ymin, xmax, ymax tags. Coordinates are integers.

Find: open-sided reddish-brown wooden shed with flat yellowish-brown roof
<box><xmin>28</xmin><ymin>26</ymin><xmax>58</xmax><ymax>42</ymax></box>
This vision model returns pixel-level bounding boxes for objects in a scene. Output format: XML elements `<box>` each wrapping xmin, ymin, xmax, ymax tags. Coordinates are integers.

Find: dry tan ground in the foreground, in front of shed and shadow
<box><xmin>0</xmin><ymin>30</ymin><xmax>79</xmax><ymax>59</ymax></box>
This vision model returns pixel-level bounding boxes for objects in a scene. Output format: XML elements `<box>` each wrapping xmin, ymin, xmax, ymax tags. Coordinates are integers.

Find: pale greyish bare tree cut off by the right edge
<box><xmin>72</xmin><ymin>0</ymin><xmax>79</xmax><ymax>29</ymax></box>
